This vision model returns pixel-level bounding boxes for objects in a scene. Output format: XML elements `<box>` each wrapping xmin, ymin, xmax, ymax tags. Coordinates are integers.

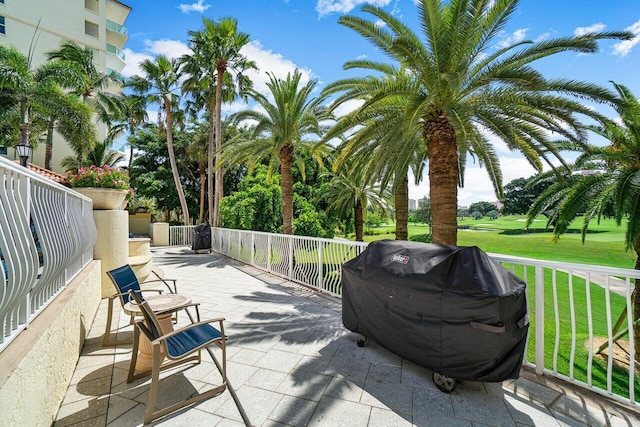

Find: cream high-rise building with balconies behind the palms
<box><xmin>0</xmin><ymin>0</ymin><xmax>131</xmax><ymax>172</ymax></box>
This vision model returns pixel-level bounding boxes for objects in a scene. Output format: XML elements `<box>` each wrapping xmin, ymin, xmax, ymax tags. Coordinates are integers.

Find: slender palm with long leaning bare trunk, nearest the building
<box><xmin>130</xmin><ymin>55</ymin><xmax>191</xmax><ymax>225</ymax></box>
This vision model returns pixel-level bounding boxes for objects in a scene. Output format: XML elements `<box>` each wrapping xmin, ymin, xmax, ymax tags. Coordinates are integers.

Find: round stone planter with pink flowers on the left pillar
<box><xmin>69</xmin><ymin>165</ymin><xmax>131</xmax><ymax>210</ymax></box>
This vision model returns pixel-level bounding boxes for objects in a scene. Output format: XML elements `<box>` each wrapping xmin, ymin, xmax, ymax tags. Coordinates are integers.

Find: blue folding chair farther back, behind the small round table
<box><xmin>102</xmin><ymin>264</ymin><xmax>178</xmax><ymax>346</ymax></box>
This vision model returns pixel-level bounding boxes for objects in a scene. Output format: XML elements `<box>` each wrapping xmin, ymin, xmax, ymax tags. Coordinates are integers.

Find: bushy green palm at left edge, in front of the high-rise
<box><xmin>0</xmin><ymin>45</ymin><xmax>94</xmax><ymax>166</ymax></box>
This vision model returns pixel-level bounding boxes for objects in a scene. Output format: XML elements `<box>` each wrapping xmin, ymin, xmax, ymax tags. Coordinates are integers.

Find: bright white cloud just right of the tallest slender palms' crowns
<box><xmin>240</xmin><ymin>41</ymin><xmax>314</xmax><ymax>95</ymax></box>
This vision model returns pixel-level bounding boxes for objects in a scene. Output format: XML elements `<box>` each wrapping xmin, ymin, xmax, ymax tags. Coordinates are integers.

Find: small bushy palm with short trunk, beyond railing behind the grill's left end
<box><xmin>324</xmin><ymin>162</ymin><xmax>391</xmax><ymax>242</ymax></box>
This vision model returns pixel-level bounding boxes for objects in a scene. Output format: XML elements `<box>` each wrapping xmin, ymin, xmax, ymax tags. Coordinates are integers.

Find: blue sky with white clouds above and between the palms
<box><xmin>123</xmin><ymin>0</ymin><xmax>640</xmax><ymax>206</ymax></box>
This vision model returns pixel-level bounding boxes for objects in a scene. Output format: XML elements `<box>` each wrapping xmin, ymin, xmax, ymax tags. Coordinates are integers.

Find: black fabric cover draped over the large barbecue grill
<box><xmin>342</xmin><ymin>240</ymin><xmax>529</xmax><ymax>381</ymax></box>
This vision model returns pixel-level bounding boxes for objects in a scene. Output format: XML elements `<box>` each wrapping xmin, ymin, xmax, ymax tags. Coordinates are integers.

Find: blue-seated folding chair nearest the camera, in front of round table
<box><xmin>127</xmin><ymin>291</ymin><xmax>227</xmax><ymax>424</ymax></box>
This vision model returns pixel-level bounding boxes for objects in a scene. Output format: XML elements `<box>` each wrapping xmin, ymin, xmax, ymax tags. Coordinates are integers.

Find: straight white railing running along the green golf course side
<box><xmin>170</xmin><ymin>227</ymin><xmax>640</xmax><ymax>407</ymax></box>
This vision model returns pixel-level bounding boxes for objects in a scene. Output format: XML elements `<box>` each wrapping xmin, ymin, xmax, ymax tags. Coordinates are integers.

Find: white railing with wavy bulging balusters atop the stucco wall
<box><xmin>0</xmin><ymin>157</ymin><xmax>97</xmax><ymax>351</ymax></box>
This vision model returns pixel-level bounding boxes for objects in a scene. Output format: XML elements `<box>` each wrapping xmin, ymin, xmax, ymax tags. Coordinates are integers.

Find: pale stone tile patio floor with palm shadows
<box><xmin>54</xmin><ymin>247</ymin><xmax>640</xmax><ymax>427</ymax></box>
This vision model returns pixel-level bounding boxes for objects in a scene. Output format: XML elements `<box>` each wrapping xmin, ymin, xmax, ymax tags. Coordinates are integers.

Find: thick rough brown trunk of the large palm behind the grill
<box><xmin>423</xmin><ymin>114</ymin><xmax>459</xmax><ymax>245</ymax></box>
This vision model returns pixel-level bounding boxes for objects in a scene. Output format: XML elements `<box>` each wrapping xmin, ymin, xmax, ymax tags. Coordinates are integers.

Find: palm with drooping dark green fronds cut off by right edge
<box><xmin>525</xmin><ymin>83</ymin><xmax>640</xmax><ymax>357</ymax></box>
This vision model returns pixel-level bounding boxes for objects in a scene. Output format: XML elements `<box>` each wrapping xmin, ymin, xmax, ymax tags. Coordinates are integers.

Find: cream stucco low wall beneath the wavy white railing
<box><xmin>0</xmin><ymin>261</ymin><xmax>100</xmax><ymax>426</ymax></box>
